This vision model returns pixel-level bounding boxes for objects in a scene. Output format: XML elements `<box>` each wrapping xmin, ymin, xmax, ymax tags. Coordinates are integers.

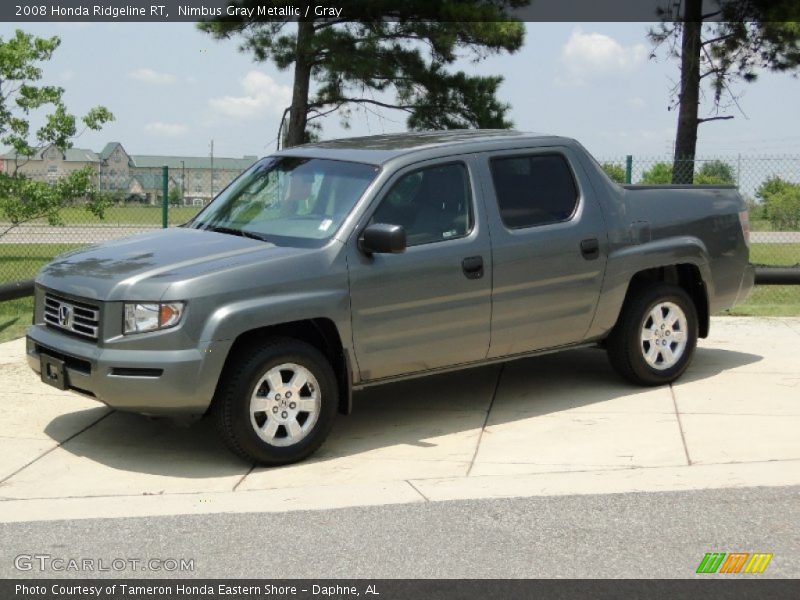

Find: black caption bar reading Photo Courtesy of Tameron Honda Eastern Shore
<box><xmin>0</xmin><ymin>574</ymin><xmax>800</xmax><ymax>600</ymax></box>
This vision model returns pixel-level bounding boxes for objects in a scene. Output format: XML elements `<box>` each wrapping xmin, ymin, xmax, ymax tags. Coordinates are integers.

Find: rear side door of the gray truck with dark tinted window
<box><xmin>481</xmin><ymin>147</ymin><xmax>608</xmax><ymax>357</ymax></box>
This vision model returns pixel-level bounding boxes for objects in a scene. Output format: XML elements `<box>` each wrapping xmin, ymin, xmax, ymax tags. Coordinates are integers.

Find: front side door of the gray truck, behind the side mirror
<box><xmin>347</xmin><ymin>158</ymin><xmax>492</xmax><ymax>381</ymax></box>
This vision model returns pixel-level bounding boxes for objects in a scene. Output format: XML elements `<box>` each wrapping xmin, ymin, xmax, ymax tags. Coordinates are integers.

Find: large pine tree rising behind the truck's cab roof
<box><xmin>199</xmin><ymin>0</ymin><xmax>530</xmax><ymax>146</ymax></box>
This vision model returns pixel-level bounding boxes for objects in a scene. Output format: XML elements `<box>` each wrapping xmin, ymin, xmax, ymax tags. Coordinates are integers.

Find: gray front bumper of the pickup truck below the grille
<box><xmin>26</xmin><ymin>325</ymin><xmax>231</xmax><ymax>417</ymax></box>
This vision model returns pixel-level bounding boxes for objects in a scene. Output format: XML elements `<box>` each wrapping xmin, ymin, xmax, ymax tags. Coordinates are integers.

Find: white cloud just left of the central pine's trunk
<box><xmin>208</xmin><ymin>71</ymin><xmax>292</xmax><ymax>119</ymax></box>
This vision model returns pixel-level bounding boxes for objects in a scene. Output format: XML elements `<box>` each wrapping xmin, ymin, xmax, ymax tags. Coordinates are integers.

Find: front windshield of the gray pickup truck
<box><xmin>193</xmin><ymin>156</ymin><xmax>379</xmax><ymax>247</ymax></box>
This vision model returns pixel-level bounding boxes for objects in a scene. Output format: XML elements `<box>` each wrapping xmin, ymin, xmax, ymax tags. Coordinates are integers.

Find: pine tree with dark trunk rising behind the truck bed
<box><xmin>649</xmin><ymin>0</ymin><xmax>800</xmax><ymax>183</ymax></box>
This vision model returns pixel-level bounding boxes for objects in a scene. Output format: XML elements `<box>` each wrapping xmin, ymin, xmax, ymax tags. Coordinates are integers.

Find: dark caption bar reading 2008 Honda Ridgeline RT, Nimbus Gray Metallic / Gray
<box><xmin>0</xmin><ymin>0</ymin><xmax>800</xmax><ymax>23</ymax></box>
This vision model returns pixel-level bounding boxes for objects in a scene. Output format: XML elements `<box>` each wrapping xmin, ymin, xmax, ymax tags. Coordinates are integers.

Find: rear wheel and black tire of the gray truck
<box><xmin>606</xmin><ymin>283</ymin><xmax>697</xmax><ymax>386</ymax></box>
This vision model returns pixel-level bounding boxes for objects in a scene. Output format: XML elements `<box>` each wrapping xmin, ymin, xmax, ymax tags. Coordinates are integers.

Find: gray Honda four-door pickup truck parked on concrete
<box><xmin>27</xmin><ymin>131</ymin><xmax>753</xmax><ymax>465</ymax></box>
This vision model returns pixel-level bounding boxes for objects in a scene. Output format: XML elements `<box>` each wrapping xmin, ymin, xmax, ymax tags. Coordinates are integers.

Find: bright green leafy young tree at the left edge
<box><xmin>0</xmin><ymin>30</ymin><xmax>114</xmax><ymax>237</ymax></box>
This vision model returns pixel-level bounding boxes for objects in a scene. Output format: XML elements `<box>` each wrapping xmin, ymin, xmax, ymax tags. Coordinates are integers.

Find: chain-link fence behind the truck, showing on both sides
<box><xmin>0</xmin><ymin>156</ymin><xmax>800</xmax><ymax>315</ymax></box>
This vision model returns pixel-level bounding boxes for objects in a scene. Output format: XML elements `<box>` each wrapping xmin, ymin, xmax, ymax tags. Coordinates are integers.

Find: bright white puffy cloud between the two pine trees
<box><xmin>556</xmin><ymin>27</ymin><xmax>647</xmax><ymax>85</ymax></box>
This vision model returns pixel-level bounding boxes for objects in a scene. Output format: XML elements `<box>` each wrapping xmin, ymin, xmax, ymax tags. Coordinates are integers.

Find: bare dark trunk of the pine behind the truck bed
<box><xmin>672</xmin><ymin>0</ymin><xmax>703</xmax><ymax>183</ymax></box>
